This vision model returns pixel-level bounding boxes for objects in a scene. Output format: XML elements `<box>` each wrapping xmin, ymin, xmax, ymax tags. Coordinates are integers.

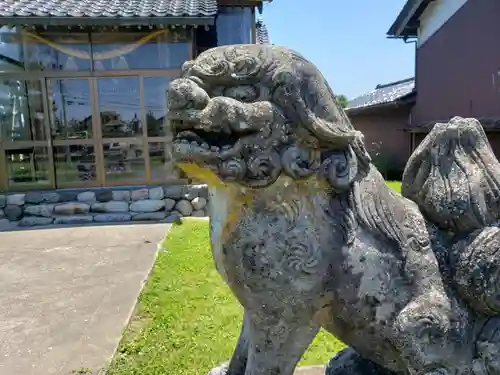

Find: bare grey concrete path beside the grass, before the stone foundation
<box><xmin>0</xmin><ymin>224</ymin><xmax>168</xmax><ymax>375</ymax></box>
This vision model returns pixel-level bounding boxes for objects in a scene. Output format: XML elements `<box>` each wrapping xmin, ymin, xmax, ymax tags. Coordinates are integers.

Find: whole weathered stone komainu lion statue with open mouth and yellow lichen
<box><xmin>168</xmin><ymin>45</ymin><xmax>500</xmax><ymax>375</ymax></box>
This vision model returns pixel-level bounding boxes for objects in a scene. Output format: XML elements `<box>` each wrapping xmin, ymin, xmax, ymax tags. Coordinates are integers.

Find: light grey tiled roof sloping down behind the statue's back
<box><xmin>346</xmin><ymin>78</ymin><xmax>415</xmax><ymax>112</ymax></box>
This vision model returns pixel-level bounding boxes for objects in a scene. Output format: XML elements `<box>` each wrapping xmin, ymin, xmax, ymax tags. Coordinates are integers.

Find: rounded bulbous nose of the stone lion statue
<box><xmin>167</xmin><ymin>78</ymin><xmax>210</xmax><ymax>111</ymax></box>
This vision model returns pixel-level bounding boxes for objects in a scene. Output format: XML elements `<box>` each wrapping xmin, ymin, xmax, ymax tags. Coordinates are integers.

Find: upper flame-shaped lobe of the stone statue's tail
<box><xmin>401</xmin><ymin>117</ymin><xmax>500</xmax><ymax>233</ymax></box>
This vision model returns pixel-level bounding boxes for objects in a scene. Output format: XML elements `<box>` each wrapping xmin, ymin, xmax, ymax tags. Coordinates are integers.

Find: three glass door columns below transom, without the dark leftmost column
<box><xmin>46</xmin><ymin>76</ymin><xmax>180</xmax><ymax>188</ymax></box>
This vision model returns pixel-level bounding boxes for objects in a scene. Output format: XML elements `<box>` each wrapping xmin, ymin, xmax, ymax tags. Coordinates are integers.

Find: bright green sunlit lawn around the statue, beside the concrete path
<box><xmin>107</xmin><ymin>182</ymin><xmax>399</xmax><ymax>375</ymax></box>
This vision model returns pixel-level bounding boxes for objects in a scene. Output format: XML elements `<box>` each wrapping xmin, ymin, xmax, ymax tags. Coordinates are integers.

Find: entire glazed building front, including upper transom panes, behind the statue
<box><xmin>0</xmin><ymin>26</ymin><xmax>190</xmax><ymax>192</ymax></box>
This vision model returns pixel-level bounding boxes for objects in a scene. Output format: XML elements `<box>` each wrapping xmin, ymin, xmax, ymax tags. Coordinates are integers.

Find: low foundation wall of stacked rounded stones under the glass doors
<box><xmin>0</xmin><ymin>185</ymin><xmax>208</xmax><ymax>231</ymax></box>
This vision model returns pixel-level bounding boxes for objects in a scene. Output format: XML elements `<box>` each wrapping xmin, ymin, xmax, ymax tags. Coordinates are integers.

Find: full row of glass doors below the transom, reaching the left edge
<box><xmin>0</xmin><ymin>73</ymin><xmax>183</xmax><ymax>191</ymax></box>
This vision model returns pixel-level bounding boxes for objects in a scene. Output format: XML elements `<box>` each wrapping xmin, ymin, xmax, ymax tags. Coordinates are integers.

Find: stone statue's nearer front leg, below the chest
<box><xmin>245</xmin><ymin>311</ymin><xmax>320</xmax><ymax>375</ymax></box>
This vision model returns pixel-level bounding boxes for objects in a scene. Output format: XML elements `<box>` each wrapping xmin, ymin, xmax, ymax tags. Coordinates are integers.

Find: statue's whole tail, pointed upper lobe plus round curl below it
<box><xmin>401</xmin><ymin>117</ymin><xmax>500</xmax><ymax>316</ymax></box>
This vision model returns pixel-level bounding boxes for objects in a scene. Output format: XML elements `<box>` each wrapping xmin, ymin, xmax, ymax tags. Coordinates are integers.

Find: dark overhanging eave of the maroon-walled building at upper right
<box><xmin>387</xmin><ymin>0</ymin><xmax>434</xmax><ymax>38</ymax></box>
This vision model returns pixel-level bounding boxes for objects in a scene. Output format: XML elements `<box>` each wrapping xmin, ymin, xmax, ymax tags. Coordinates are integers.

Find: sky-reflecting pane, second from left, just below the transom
<box><xmin>47</xmin><ymin>79</ymin><xmax>92</xmax><ymax>139</ymax></box>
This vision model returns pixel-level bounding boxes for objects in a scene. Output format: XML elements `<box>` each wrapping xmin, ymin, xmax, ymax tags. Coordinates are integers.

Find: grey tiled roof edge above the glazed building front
<box><xmin>0</xmin><ymin>0</ymin><xmax>218</xmax><ymax>23</ymax></box>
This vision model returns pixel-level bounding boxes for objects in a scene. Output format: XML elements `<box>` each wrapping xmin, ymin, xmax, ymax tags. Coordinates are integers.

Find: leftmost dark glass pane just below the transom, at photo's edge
<box><xmin>0</xmin><ymin>79</ymin><xmax>47</xmax><ymax>142</ymax></box>
